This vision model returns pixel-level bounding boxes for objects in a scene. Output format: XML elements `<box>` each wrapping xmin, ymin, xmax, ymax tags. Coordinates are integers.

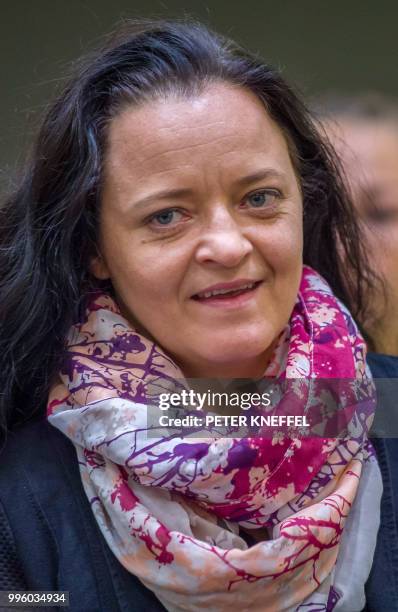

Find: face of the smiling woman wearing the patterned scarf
<box><xmin>92</xmin><ymin>84</ymin><xmax>303</xmax><ymax>377</ymax></box>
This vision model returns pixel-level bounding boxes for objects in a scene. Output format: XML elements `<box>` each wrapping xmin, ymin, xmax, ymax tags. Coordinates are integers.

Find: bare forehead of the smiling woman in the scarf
<box><xmin>105</xmin><ymin>83</ymin><xmax>290</xmax><ymax>177</ymax></box>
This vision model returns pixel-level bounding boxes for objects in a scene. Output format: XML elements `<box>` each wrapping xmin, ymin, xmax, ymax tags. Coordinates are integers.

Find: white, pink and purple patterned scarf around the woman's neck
<box><xmin>48</xmin><ymin>267</ymin><xmax>381</xmax><ymax>612</ymax></box>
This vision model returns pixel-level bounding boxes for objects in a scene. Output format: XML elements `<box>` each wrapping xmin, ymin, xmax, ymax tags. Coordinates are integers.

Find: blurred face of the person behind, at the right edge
<box><xmin>327</xmin><ymin>118</ymin><xmax>398</xmax><ymax>355</ymax></box>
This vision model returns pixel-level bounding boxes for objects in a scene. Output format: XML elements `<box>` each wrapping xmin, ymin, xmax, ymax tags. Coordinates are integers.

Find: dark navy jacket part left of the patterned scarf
<box><xmin>0</xmin><ymin>419</ymin><xmax>163</xmax><ymax>612</ymax></box>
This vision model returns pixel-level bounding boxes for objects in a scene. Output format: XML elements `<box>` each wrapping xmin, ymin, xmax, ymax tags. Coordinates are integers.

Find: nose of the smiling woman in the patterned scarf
<box><xmin>196</xmin><ymin>207</ymin><xmax>253</xmax><ymax>268</ymax></box>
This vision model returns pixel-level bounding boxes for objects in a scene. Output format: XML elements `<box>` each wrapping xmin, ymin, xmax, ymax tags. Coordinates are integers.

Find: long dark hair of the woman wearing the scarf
<box><xmin>0</xmin><ymin>21</ymin><xmax>370</xmax><ymax>438</ymax></box>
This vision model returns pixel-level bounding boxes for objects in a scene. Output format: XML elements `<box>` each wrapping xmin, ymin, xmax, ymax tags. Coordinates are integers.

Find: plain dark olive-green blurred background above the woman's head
<box><xmin>0</xmin><ymin>0</ymin><xmax>398</xmax><ymax>179</ymax></box>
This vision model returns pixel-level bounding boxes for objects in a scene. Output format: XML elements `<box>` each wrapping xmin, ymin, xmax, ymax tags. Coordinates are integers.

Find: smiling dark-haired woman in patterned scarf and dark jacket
<box><xmin>1</xmin><ymin>23</ymin><xmax>397</xmax><ymax>611</ymax></box>
